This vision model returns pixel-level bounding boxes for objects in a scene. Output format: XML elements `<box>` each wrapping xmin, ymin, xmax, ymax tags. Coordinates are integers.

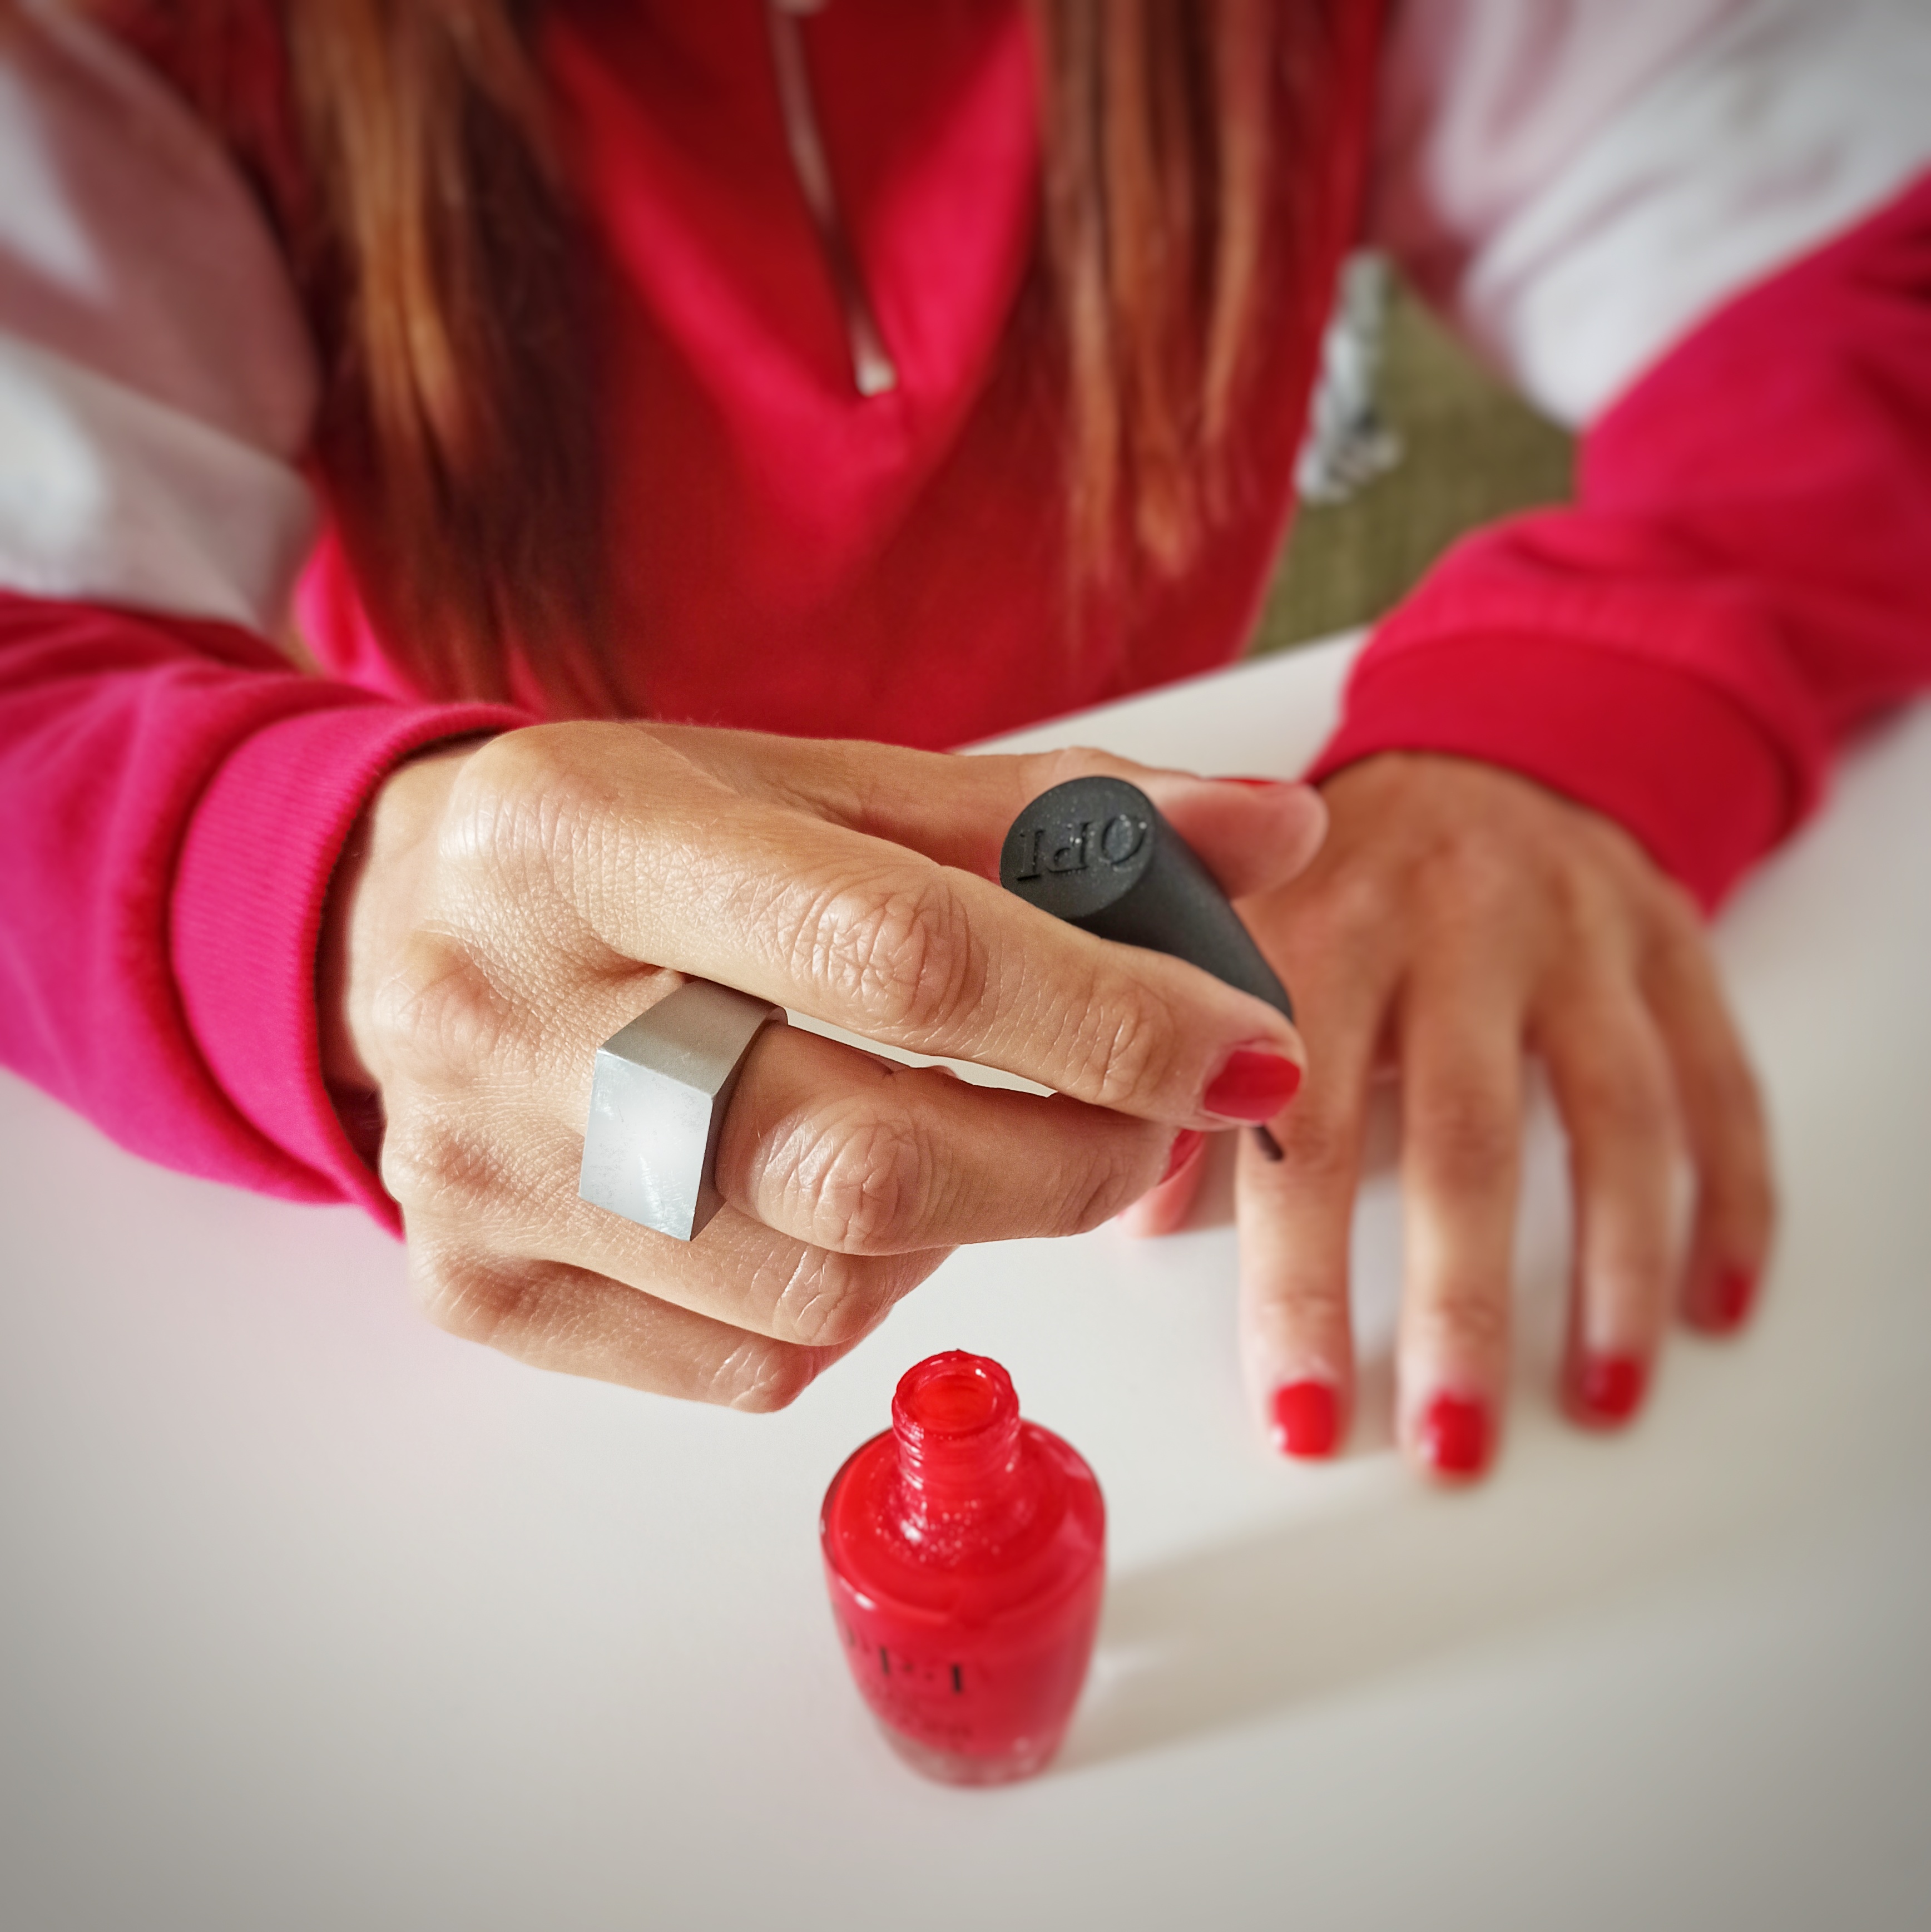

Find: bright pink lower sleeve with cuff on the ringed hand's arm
<box><xmin>0</xmin><ymin>591</ymin><xmax>527</xmax><ymax>1229</ymax></box>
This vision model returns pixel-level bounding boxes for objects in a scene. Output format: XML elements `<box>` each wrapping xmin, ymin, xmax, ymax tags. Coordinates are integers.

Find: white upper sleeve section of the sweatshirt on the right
<box><xmin>1377</xmin><ymin>0</ymin><xmax>1931</xmax><ymax>427</ymax></box>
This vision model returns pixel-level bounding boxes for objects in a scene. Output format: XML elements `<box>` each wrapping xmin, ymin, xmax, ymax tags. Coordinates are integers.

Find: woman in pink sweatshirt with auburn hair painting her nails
<box><xmin>0</xmin><ymin>0</ymin><xmax>1931</xmax><ymax>1478</ymax></box>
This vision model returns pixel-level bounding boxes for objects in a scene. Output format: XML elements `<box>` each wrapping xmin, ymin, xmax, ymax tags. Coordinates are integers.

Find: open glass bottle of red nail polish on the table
<box><xmin>821</xmin><ymin>1348</ymin><xmax>1106</xmax><ymax>1785</ymax></box>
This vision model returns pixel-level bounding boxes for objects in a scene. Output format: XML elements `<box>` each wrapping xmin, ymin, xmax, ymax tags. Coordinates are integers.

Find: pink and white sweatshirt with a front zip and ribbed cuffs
<box><xmin>0</xmin><ymin>0</ymin><xmax>1931</xmax><ymax>1225</ymax></box>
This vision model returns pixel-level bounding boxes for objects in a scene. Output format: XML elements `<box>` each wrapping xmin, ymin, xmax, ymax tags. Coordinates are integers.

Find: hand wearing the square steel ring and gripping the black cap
<box><xmin>323</xmin><ymin>724</ymin><xmax>1325</xmax><ymax>1409</ymax></box>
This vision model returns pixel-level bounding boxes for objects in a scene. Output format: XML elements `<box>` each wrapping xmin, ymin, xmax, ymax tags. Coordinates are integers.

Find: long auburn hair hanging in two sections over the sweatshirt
<box><xmin>93</xmin><ymin>0</ymin><xmax>1348</xmax><ymax>715</ymax></box>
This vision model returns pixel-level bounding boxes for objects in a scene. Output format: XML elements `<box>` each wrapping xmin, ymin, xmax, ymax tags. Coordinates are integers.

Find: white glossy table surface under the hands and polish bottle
<box><xmin>11</xmin><ymin>649</ymin><xmax>1931</xmax><ymax>1932</ymax></box>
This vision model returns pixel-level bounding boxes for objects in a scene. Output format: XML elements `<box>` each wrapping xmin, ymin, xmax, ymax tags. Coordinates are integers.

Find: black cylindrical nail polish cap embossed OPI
<box><xmin>998</xmin><ymin>779</ymin><xmax>1294</xmax><ymax>1020</ymax></box>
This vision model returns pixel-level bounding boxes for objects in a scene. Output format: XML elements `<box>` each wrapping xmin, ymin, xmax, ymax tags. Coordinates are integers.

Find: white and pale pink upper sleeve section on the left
<box><xmin>0</xmin><ymin>4</ymin><xmax>316</xmax><ymax>632</ymax></box>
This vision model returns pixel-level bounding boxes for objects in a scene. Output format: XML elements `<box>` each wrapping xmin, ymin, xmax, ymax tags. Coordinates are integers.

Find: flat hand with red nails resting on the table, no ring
<box><xmin>1130</xmin><ymin>753</ymin><xmax>1772</xmax><ymax>1476</ymax></box>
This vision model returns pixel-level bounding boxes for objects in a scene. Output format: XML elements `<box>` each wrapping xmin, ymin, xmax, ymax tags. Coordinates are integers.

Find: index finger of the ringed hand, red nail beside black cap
<box><xmin>458</xmin><ymin>727</ymin><xmax>1304</xmax><ymax>1126</ymax></box>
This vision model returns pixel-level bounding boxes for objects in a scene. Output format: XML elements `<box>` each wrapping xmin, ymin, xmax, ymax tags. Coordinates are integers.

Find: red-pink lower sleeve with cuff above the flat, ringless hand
<box><xmin>1313</xmin><ymin>178</ymin><xmax>1931</xmax><ymax>906</ymax></box>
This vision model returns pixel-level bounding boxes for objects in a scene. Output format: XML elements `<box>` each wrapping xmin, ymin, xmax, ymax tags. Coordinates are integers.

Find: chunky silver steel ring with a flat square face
<box><xmin>577</xmin><ymin>980</ymin><xmax>784</xmax><ymax>1241</ymax></box>
